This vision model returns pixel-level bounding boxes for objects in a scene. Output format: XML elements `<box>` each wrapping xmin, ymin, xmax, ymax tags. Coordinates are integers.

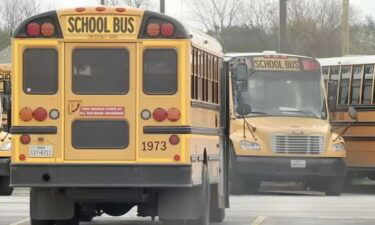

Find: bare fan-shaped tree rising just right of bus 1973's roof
<box><xmin>190</xmin><ymin>0</ymin><xmax>241</xmax><ymax>40</ymax></box>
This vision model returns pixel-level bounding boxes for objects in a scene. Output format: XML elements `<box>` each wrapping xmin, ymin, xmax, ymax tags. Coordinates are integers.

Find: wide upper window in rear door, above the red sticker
<box><xmin>72</xmin><ymin>49</ymin><xmax>129</xmax><ymax>95</ymax></box>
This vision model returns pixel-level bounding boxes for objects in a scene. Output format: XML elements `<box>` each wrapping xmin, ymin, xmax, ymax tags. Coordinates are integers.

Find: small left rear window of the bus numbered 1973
<box><xmin>23</xmin><ymin>48</ymin><xmax>58</xmax><ymax>95</ymax></box>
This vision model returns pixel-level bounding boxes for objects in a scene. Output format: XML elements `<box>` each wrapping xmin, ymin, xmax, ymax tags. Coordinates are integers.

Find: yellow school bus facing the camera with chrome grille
<box><xmin>226</xmin><ymin>51</ymin><xmax>346</xmax><ymax>195</ymax></box>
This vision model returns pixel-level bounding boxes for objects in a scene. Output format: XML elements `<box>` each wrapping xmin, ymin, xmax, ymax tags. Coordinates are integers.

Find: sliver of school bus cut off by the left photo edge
<box><xmin>0</xmin><ymin>64</ymin><xmax>13</xmax><ymax>195</ymax></box>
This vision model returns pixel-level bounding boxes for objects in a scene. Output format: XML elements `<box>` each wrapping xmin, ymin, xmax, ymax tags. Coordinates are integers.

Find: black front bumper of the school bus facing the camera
<box><xmin>235</xmin><ymin>157</ymin><xmax>346</xmax><ymax>180</ymax></box>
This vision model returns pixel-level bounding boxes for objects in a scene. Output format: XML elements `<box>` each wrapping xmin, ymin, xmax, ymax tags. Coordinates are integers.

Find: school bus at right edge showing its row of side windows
<box><xmin>318</xmin><ymin>56</ymin><xmax>375</xmax><ymax>183</ymax></box>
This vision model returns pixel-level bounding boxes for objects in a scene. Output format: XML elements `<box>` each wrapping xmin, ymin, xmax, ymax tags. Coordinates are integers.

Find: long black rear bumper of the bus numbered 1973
<box><xmin>10</xmin><ymin>164</ymin><xmax>192</xmax><ymax>188</ymax></box>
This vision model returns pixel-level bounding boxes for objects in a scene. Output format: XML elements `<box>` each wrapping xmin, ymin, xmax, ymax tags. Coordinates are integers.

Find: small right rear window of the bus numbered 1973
<box><xmin>143</xmin><ymin>49</ymin><xmax>177</xmax><ymax>95</ymax></box>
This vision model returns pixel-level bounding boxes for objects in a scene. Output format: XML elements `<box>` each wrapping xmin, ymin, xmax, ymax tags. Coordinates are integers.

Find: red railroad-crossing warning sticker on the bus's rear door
<box><xmin>79</xmin><ymin>106</ymin><xmax>125</xmax><ymax>116</ymax></box>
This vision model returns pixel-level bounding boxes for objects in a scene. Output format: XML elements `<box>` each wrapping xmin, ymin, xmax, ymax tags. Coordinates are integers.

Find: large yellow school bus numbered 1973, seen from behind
<box><xmin>11</xmin><ymin>7</ymin><xmax>228</xmax><ymax>225</ymax></box>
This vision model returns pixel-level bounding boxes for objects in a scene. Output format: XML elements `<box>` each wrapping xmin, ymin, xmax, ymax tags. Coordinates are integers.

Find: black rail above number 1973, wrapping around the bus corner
<box><xmin>143</xmin><ymin>126</ymin><xmax>223</xmax><ymax>135</ymax></box>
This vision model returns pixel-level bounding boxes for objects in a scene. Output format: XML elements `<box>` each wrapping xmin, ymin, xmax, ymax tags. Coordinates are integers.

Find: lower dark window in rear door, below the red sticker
<box><xmin>72</xmin><ymin>120</ymin><xmax>129</xmax><ymax>149</ymax></box>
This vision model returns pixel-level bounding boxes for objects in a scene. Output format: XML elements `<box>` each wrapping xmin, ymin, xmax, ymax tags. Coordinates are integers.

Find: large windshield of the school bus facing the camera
<box><xmin>234</xmin><ymin>71</ymin><xmax>326</xmax><ymax>119</ymax></box>
